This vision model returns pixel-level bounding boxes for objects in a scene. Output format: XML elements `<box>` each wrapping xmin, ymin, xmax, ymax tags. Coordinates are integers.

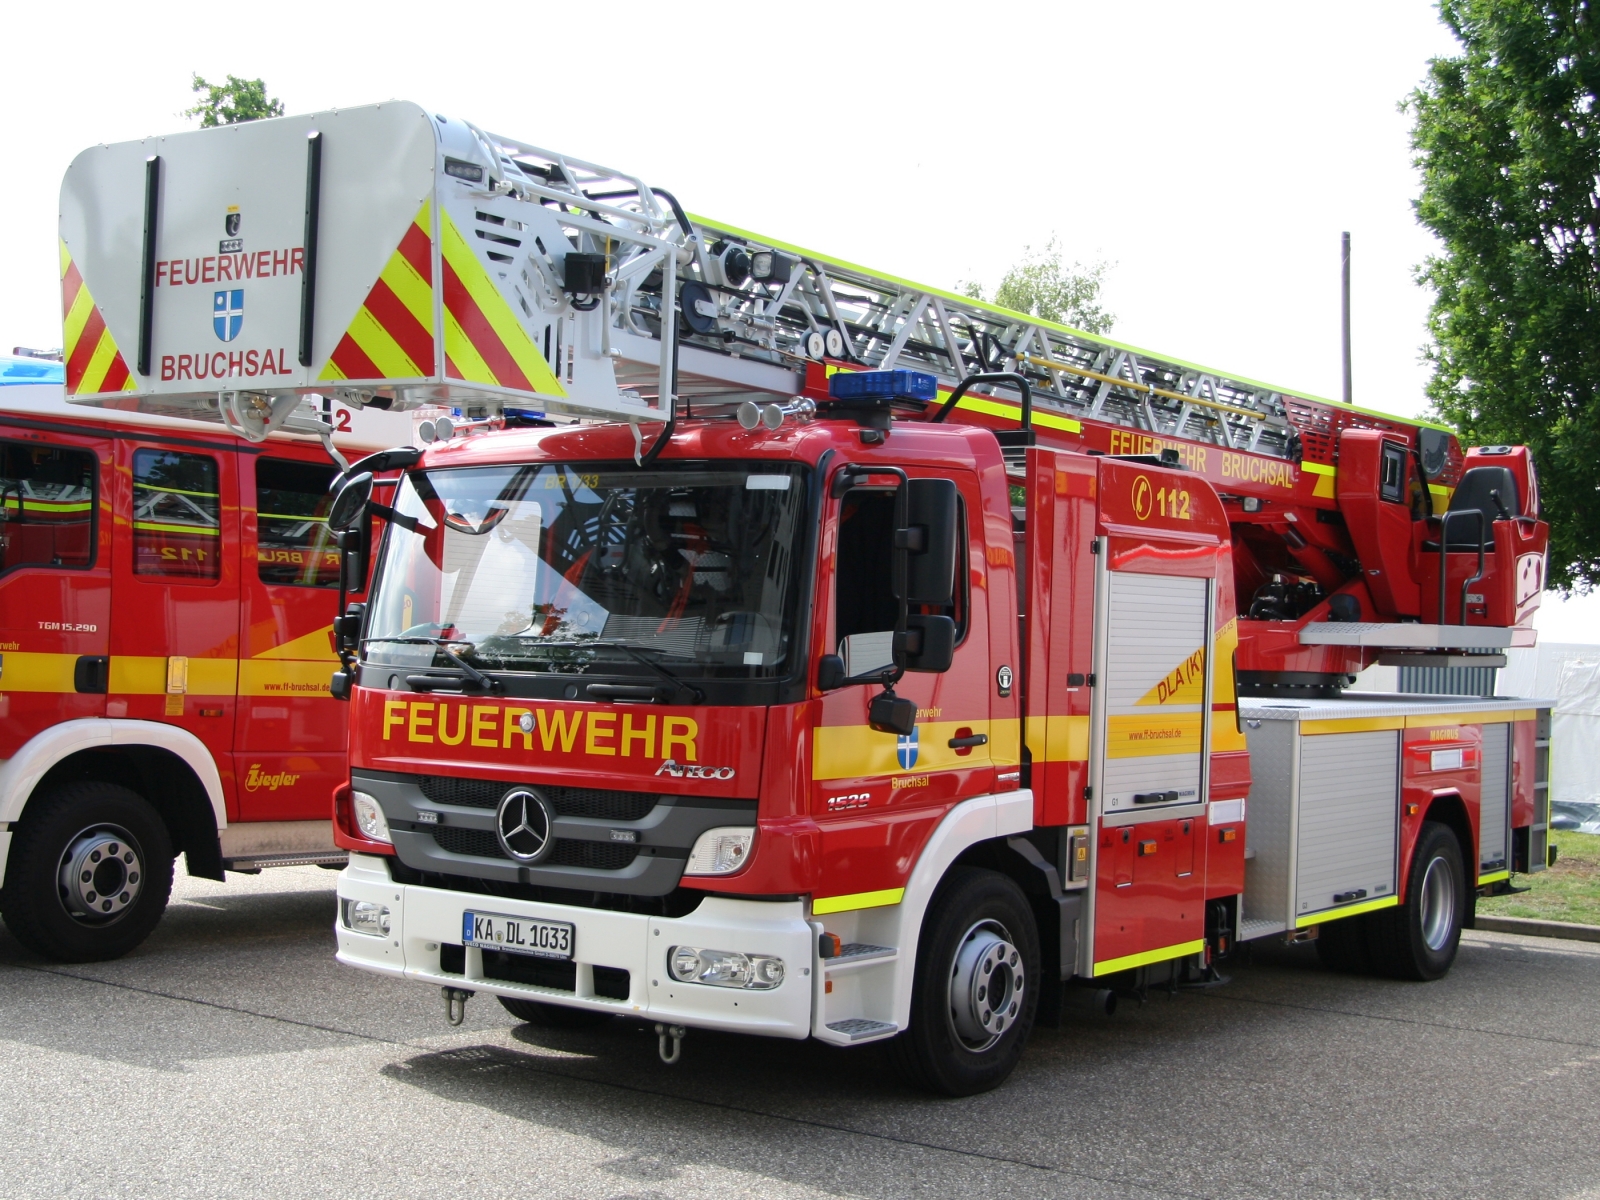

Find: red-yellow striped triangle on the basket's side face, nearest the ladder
<box><xmin>438</xmin><ymin>210</ymin><xmax>566</xmax><ymax>397</ymax></box>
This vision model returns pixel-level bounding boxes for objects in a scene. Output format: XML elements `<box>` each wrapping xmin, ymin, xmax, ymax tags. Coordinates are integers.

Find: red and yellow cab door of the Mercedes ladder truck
<box><xmin>811</xmin><ymin>467</ymin><xmax>1016</xmax><ymax>910</ymax></box>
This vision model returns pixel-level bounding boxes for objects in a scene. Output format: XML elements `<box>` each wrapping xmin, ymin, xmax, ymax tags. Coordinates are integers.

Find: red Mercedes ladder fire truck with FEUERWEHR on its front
<box><xmin>62</xmin><ymin>104</ymin><xmax>1547</xmax><ymax>1094</ymax></box>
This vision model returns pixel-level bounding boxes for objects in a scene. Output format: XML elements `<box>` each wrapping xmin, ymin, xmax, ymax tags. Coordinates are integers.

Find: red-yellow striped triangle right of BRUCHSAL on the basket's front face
<box><xmin>317</xmin><ymin>202</ymin><xmax>434</xmax><ymax>379</ymax></box>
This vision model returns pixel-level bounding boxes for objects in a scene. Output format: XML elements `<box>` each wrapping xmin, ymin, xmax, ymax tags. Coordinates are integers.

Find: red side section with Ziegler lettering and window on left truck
<box><xmin>237</xmin><ymin>443</ymin><xmax>349</xmax><ymax>821</ymax></box>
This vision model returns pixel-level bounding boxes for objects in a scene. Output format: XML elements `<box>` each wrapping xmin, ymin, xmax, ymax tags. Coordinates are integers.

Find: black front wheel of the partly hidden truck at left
<box><xmin>0</xmin><ymin>782</ymin><xmax>173</xmax><ymax>963</ymax></box>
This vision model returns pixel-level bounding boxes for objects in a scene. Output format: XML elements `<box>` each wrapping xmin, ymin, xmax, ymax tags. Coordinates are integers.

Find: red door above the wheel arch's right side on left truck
<box><xmin>106</xmin><ymin>438</ymin><xmax>238</xmax><ymax>819</ymax></box>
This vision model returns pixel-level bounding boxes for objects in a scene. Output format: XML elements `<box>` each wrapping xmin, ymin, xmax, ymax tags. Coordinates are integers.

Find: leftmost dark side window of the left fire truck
<box><xmin>0</xmin><ymin>442</ymin><xmax>96</xmax><ymax>571</ymax></box>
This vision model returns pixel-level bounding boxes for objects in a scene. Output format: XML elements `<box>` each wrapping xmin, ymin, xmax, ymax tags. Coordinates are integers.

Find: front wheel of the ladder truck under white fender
<box><xmin>888</xmin><ymin>867</ymin><xmax>1043</xmax><ymax>1096</ymax></box>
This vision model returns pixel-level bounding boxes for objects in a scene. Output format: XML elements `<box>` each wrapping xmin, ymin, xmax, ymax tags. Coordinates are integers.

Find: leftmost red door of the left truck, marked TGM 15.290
<box><xmin>0</xmin><ymin>424</ymin><xmax>112</xmax><ymax>760</ymax></box>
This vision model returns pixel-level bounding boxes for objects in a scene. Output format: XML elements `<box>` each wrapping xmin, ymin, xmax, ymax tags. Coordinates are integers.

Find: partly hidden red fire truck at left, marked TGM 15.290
<box><xmin>0</xmin><ymin>371</ymin><xmax>410</xmax><ymax>962</ymax></box>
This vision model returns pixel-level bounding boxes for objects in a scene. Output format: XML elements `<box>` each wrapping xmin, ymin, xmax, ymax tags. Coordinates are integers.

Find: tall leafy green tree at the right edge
<box><xmin>1403</xmin><ymin>0</ymin><xmax>1600</xmax><ymax>590</ymax></box>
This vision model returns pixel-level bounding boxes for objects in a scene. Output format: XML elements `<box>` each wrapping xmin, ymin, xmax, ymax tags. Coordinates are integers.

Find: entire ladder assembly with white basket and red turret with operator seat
<box><xmin>61</xmin><ymin>102</ymin><xmax>1546</xmax><ymax>678</ymax></box>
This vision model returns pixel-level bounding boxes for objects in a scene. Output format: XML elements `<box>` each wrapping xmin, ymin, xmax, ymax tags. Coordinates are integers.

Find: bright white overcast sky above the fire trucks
<box><xmin>0</xmin><ymin>0</ymin><xmax>1593</xmax><ymax>640</ymax></box>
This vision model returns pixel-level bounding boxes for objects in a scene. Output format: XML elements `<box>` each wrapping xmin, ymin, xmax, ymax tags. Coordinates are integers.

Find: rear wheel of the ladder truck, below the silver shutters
<box><xmin>1366</xmin><ymin>821</ymin><xmax>1467</xmax><ymax>981</ymax></box>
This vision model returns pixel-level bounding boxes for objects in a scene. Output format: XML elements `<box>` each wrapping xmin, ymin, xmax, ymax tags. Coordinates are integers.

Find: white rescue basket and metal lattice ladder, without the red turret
<box><xmin>61</xmin><ymin>104</ymin><xmax>1458</xmax><ymax>480</ymax></box>
